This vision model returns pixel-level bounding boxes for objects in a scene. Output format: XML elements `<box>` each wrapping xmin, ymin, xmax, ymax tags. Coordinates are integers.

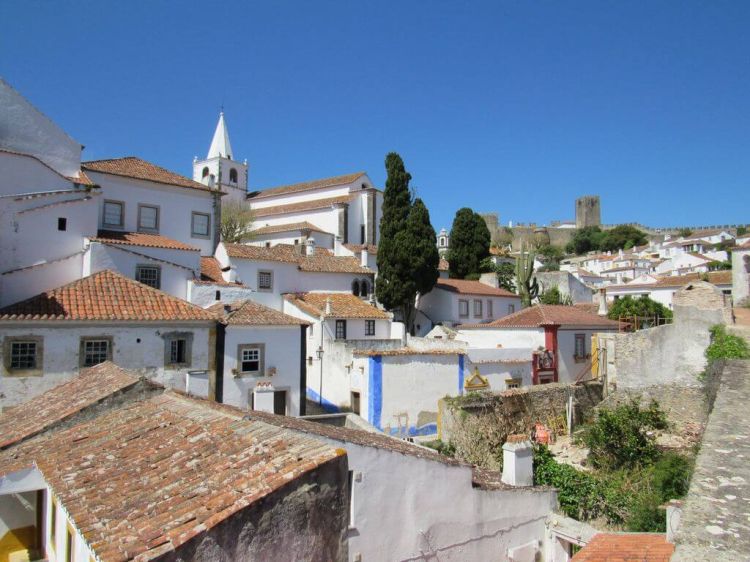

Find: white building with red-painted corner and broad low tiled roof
<box><xmin>457</xmin><ymin>304</ymin><xmax>619</xmax><ymax>384</ymax></box>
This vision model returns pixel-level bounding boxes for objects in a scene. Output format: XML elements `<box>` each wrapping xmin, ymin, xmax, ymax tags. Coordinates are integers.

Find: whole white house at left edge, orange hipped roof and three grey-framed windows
<box><xmin>0</xmin><ymin>271</ymin><xmax>216</xmax><ymax>406</ymax></box>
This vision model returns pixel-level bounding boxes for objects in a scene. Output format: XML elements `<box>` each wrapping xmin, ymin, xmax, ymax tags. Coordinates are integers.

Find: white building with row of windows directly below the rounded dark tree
<box><xmin>416</xmin><ymin>278</ymin><xmax>521</xmax><ymax>335</ymax></box>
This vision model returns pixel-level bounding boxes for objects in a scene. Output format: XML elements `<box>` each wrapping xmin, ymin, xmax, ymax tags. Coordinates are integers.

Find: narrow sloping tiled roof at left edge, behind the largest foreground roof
<box><xmin>0</xmin><ymin>361</ymin><xmax>138</xmax><ymax>449</ymax></box>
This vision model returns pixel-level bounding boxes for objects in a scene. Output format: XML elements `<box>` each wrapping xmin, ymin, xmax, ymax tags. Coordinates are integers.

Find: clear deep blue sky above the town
<box><xmin>0</xmin><ymin>0</ymin><xmax>750</xmax><ymax>229</ymax></box>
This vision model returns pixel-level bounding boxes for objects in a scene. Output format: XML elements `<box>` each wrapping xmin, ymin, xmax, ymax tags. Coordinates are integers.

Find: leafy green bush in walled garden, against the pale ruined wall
<box><xmin>583</xmin><ymin>400</ymin><xmax>667</xmax><ymax>470</ymax></box>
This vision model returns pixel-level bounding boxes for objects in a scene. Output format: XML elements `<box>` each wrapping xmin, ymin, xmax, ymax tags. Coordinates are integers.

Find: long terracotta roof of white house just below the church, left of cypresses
<box><xmin>224</xmin><ymin>243</ymin><xmax>374</xmax><ymax>274</ymax></box>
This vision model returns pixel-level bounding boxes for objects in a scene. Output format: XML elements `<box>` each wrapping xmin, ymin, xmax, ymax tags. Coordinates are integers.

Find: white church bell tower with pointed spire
<box><xmin>193</xmin><ymin>111</ymin><xmax>248</xmax><ymax>201</ymax></box>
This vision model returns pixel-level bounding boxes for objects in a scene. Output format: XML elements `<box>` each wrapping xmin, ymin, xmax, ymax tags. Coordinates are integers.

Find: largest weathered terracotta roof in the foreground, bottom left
<box><xmin>0</xmin><ymin>391</ymin><xmax>338</xmax><ymax>562</ymax></box>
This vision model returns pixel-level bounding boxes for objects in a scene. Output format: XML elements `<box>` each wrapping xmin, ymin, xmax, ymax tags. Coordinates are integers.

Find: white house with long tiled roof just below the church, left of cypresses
<box><xmin>216</xmin><ymin>240</ymin><xmax>374</xmax><ymax>310</ymax></box>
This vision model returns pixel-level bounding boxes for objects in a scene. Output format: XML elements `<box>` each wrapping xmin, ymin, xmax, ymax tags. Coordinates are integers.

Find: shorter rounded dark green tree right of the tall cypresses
<box><xmin>446</xmin><ymin>207</ymin><xmax>492</xmax><ymax>279</ymax></box>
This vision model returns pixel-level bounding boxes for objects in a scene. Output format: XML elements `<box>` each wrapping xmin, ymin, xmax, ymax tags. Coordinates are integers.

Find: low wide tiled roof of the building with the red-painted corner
<box><xmin>459</xmin><ymin>304</ymin><xmax>620</xmax><ymax>329</ymax></box>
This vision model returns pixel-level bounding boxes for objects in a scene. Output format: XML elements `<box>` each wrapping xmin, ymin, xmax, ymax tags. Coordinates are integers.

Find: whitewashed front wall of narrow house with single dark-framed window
<box><xmin>222</xmin><ymin>325</ymin><xmax>304</xmax><ymax>416</ymax></box>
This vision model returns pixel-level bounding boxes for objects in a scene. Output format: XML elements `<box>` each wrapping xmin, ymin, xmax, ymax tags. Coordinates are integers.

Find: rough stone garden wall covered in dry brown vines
<box><xmin>438</xmin><ymin>382</ymin><xmax>602</xmax><ymax>470</ymax></box>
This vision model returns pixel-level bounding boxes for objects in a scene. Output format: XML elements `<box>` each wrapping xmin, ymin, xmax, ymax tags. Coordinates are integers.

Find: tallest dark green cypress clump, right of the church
<box><xmin>375</xmin><ymin>152</ymin><xmax>440</xmax><ymax>332</ymax></box>
